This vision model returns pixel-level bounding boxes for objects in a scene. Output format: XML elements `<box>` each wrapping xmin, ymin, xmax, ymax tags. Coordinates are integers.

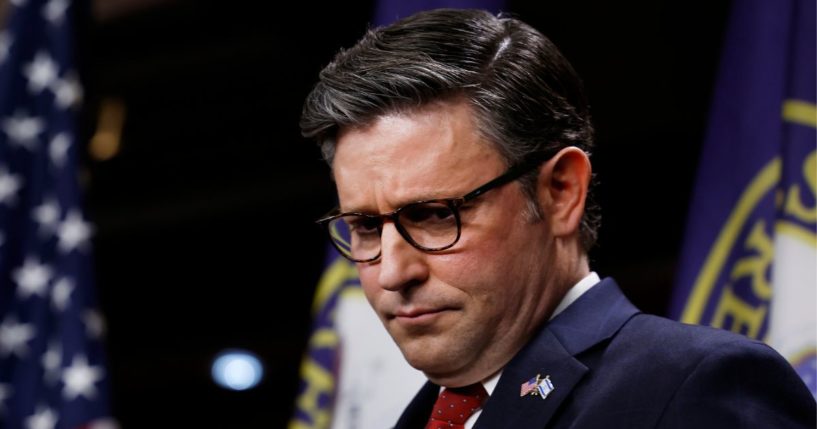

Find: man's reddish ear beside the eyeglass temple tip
<box><xmin>539</xmin><ymin>146</ymin><xmax>592</xmax><ymax>237</ymax></box>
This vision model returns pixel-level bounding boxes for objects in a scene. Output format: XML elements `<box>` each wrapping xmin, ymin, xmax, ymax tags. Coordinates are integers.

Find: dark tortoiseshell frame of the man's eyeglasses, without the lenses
<box><xmin>315</xmin><ymin>151</ymin><xmax>556</xmax><ymax>263</ymax></box>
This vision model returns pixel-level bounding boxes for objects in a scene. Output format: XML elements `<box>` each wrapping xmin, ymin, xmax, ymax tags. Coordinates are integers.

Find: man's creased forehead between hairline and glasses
<box><xmin>333</xmin><ymin>111</ymin><xmax>505</xmax><ymax>212</ymax></box>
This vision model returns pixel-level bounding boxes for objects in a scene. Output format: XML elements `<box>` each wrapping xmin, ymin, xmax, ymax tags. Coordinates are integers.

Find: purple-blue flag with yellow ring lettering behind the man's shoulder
<box><xmin>672</xmin><ymin>0</ymin><xmax>817</xmax><ymax>393</ymax></box>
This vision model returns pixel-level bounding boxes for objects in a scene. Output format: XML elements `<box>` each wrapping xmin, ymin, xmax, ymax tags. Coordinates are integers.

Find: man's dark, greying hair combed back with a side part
<box><xmin>300</xmin><ymin>9</ymin><xmax>600</xmax><ymax>250</ymax></box>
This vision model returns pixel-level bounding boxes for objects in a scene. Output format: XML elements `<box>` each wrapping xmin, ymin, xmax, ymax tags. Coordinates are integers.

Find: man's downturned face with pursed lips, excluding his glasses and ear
<box><xmin>333</xmin><ymin>99</ymin><xmax>555</xmax><ymax>386</ymax></box>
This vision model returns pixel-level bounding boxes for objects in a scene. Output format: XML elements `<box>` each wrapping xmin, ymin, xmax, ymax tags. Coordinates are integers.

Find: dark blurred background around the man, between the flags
<box><xmin>78</xmin><ymin>0</ymin><xmax>729</xmax><ymax>428</ymax></box>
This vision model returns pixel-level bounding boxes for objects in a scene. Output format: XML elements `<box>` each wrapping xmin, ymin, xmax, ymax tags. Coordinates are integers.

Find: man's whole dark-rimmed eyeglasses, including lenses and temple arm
<box><xmin>317</xmin><ymin>152</ymin><xmax>554</xmax><ymax>262</ymax></box>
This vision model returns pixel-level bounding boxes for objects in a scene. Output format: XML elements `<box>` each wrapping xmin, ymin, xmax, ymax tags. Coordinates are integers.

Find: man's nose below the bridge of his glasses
<box><xmin>378</xmin><ymin>222</ymin><xmax>429</xmax><ymax>291</ymax></box>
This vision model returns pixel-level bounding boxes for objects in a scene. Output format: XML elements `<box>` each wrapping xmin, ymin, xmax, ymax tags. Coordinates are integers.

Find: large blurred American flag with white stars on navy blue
<box><xmin>0</xmin><ymin>0</ymin><xmax>115</xmax><ymax>429</ymax></box>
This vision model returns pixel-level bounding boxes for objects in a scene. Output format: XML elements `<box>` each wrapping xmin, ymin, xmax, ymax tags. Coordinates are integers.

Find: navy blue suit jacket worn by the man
<box><xmin>395</xmin><ymin>278</ymin><xmax>817</xmax><ymax>429</ymax></box>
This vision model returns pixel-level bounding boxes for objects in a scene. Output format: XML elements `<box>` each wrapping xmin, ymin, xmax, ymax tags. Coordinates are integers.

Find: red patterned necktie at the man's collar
<box><xmin>426</xmin><ymin>383</ymin><xmax>488</xmax><ymax>429</ymax></box>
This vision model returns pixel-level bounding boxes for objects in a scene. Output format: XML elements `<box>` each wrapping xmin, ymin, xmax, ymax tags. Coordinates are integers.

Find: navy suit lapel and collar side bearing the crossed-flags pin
<box><xmin>475</xmin><ymin>279</ymin><xmax>638</xmax><ymax>429</ymax></box>
